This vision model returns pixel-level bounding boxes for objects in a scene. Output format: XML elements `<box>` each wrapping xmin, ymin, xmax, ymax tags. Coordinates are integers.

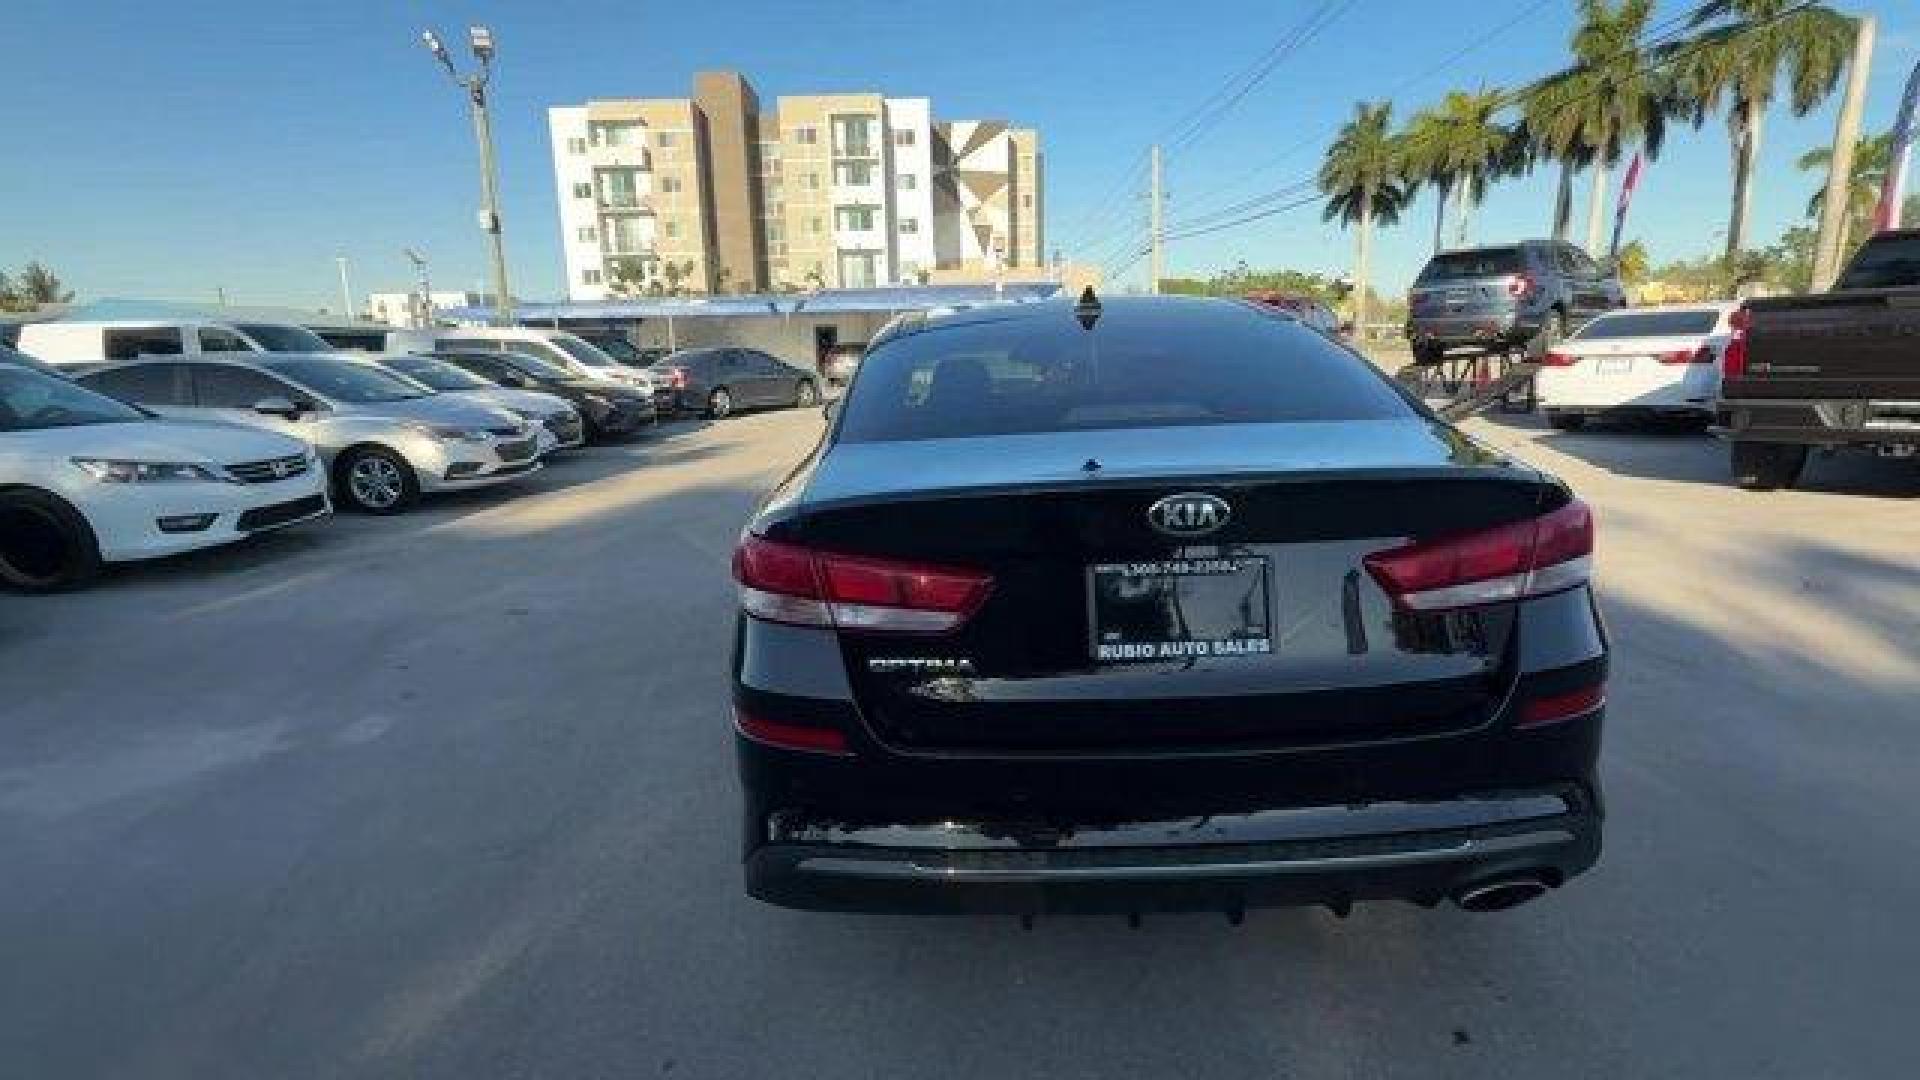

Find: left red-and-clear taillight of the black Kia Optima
<box><xmin>733</xmin><ymin>534</ymin><xmax>993</xmax><ymax>634</ymax></box>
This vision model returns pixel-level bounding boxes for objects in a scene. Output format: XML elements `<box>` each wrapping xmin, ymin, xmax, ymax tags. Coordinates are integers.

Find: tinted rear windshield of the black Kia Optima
<box><xmin>839</xmin><ymin>304</ymin><xmax>1413</xmax><ymax>442</ymax></box>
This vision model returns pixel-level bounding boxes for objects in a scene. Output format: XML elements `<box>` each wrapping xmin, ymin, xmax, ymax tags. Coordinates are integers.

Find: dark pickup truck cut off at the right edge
<box><xmin>1716</xmin><ymin>229</ymin><xmax>1920</xmax><ymax>490</ymax></box>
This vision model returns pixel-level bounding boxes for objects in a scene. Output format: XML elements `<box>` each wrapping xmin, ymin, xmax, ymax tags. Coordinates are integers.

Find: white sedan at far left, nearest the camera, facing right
<box><xmin>0</xmin><ymin>359</ymin><xmax>332</xmax><ymax>592</ymax></box>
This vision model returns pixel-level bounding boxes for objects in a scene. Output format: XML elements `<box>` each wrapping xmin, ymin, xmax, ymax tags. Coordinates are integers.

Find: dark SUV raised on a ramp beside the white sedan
<box><xmin>1407</xmin><ymin>240</ymin><xmax>1626</xmax><ymax>363</ymax></box>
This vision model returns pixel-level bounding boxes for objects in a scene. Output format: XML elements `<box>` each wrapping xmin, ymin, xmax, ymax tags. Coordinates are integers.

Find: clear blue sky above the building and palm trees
<box><xmin>0</xmin><ymin>0</ymin><xmax>1920</xmax><ymax>307</ymax></box>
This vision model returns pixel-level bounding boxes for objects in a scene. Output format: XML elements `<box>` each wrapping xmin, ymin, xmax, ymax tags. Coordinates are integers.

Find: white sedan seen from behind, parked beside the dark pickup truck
<box><xmin>1534</xmin><ymin>304</ymin><xmax>1740</xmax><ymax>430</ymax></box>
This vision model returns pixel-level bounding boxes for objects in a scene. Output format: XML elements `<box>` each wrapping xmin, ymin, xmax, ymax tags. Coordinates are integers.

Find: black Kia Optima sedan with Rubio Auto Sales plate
<box><xmin>733</xmin><ymin>294</ymin><xmax>1607</xmax><ymax>920</ymax></box>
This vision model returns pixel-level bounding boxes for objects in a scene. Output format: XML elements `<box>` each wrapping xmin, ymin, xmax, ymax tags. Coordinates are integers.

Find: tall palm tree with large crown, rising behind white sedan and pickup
<box><xmin>1672</xmin><ymin>0</ymin><xmax>1855</xmax><ymax>258</ymax></box>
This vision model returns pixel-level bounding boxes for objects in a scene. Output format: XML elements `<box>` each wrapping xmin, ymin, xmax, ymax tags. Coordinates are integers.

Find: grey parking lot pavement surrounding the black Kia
<box><xmin>0</xmin><ymin>411</ymin><xmax>1920</xmax><ymax>1078</ymax></box>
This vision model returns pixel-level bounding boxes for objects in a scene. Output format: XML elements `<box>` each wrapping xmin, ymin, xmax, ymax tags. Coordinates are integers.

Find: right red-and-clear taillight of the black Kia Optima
<box><xmin>1363</xmin><ymin>500</ymin><xmax>1594</xmax><ymax>611</ymax></box>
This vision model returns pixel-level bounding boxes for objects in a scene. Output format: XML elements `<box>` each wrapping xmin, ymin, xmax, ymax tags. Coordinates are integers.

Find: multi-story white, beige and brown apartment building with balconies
<box><xmin>547</xmin><ymin>71</ymin><xmax>1044</xmax><ymax>300</ymax></box>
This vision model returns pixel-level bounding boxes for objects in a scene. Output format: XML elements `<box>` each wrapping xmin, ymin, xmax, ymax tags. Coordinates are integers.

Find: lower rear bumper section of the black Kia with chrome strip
<box><xmin>747</xmin><ymin>784</ymin><xmax>1601</xmax><ymax>915</ymax></box>
